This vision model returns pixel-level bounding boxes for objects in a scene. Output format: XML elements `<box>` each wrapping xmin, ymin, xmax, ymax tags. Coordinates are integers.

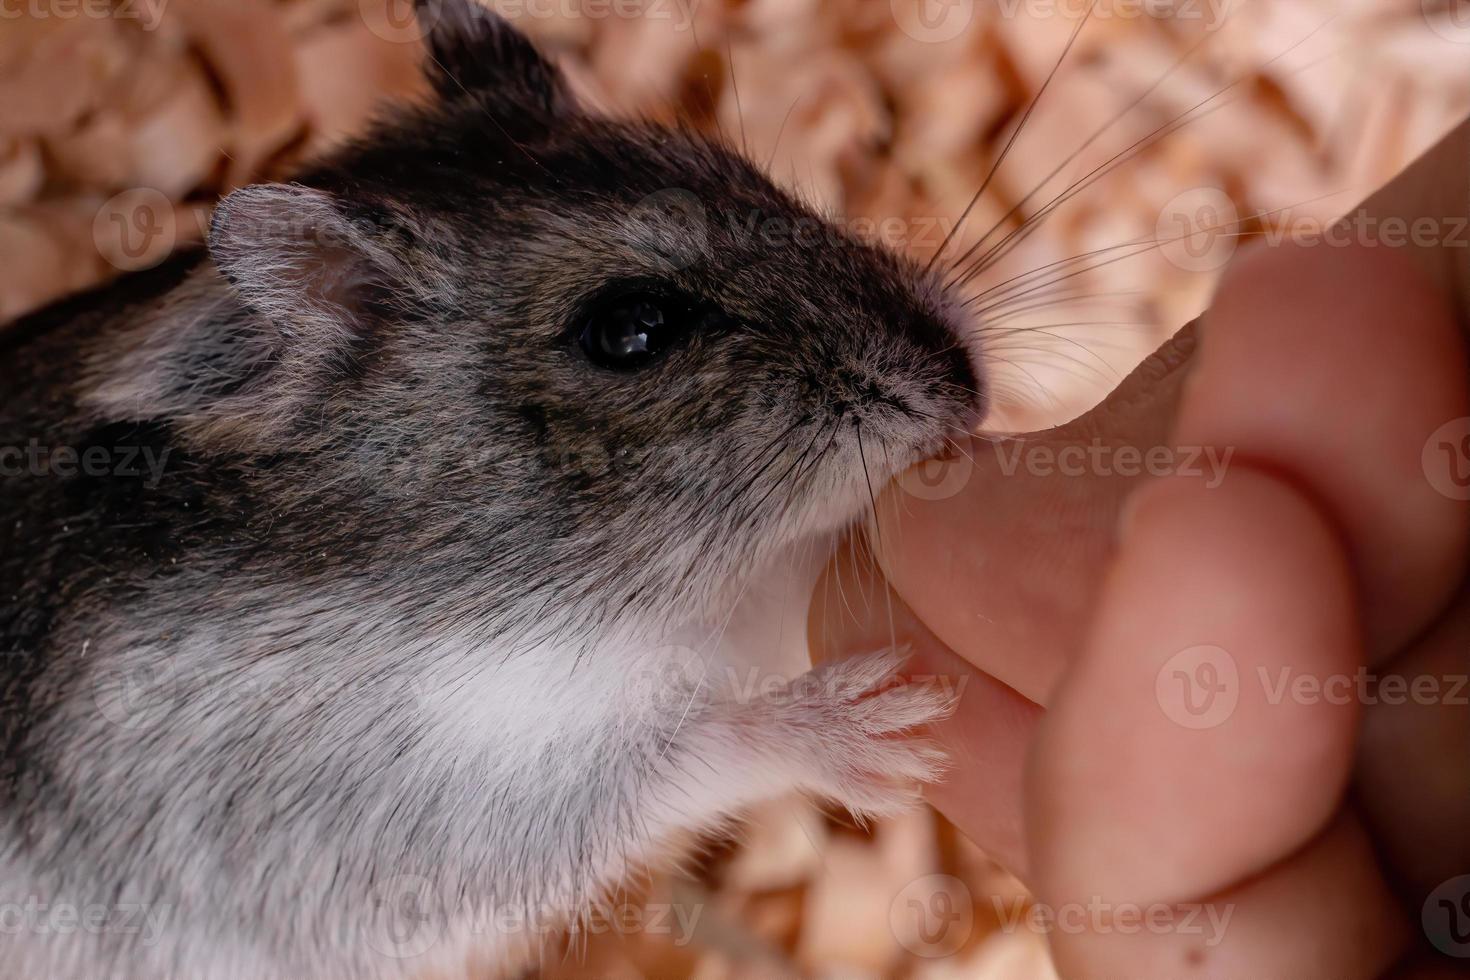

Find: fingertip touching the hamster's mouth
<box><xmin>878</xmin><ymin>328</ymin><xmax>1192</xmax><ymax>704</ymax></box>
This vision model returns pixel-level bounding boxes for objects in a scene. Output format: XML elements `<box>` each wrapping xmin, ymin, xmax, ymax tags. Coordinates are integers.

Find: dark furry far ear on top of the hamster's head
<box><xmin>416</xmin><ymin>0</ymin><xmax>572</xmax><ymax>115</ymax></box>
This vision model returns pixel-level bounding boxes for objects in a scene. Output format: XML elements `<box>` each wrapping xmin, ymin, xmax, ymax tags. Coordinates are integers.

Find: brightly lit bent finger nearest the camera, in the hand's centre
<box><xmin>1028</xmin><ymin>469</ymin><xmax>1358</xmax><ymax>902</ymax></box>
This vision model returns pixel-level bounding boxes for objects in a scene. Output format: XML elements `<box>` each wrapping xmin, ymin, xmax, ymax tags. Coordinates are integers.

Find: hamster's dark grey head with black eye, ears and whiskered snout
<box><xmin>186</xmin><ymin>0</ymin><xmax>985</xmax><ymax>637</ymax></box>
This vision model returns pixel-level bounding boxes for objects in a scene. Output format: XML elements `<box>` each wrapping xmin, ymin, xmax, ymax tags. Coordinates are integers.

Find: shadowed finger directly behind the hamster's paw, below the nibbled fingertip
<box><xmin>807</xmin><ymin>545</ymin><xmax>1041</xmax><ymax>877</ymax></box>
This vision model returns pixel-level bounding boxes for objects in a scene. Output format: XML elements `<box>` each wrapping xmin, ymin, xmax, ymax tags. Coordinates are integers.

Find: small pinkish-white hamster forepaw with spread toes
<box><xmin>784</xmin><ymin>651</ymin><xmax>957</xmax><ymax>818</ymax></box>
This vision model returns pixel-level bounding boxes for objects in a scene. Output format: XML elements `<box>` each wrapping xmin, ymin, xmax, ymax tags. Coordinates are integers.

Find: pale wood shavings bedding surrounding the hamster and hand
<box><xmin>0</xmin><ymin>0</ymin><xmax>1470</xmax><ymax>980</ymax></box>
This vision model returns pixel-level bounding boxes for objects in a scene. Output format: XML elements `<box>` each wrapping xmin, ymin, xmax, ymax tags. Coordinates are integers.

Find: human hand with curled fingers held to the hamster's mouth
<box><xmin>810</xmin><ymin>116</ymin><xmax>1470</xmax><ymax>980</ymax></box>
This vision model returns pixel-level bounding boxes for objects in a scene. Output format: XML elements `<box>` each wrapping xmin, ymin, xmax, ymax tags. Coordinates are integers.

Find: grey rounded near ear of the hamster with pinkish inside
<box><xmin>209</xmin><ymin>184</ymin><xmax>404</xmax><ymax>347</ymax></box>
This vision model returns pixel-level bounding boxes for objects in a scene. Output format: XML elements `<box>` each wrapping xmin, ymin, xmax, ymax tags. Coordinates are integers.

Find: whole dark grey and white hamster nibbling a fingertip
<box><xmin>0</xmin><ymin>0</ymin><xmax>985</xmax><ymax>980</ymax></box>
